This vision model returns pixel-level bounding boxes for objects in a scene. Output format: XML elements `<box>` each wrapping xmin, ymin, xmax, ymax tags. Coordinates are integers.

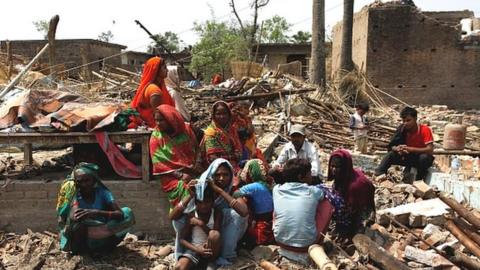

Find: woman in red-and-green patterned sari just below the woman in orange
<box><xmin>150</xmin><ymin>105</ymin><xmax>199</xmax><ymax>210</ymax></box>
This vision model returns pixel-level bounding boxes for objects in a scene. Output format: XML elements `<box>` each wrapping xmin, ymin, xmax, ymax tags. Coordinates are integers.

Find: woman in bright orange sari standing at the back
<box><xmin>131</xmin><ymin>56</ymin><xmax>175</xmax><ymax>128</ymax></box>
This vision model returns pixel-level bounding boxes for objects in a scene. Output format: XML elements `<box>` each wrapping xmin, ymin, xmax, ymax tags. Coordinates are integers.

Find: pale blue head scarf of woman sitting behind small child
<box><xmin>185</xmin><ymin>158</ymin><xmax>233</xmax><ymax>213</ymax></box>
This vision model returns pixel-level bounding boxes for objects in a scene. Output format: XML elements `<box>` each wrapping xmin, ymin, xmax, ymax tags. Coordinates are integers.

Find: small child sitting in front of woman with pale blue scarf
<box><xmin>175</xmin><ymin>186</ymin><xmax>222</xmax><ymax>269</ymax></box>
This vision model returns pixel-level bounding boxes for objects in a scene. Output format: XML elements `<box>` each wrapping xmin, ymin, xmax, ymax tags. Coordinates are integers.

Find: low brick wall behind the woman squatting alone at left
<box><xmin>0</xmin><ymin>180</ymin><xmax>174</xmax><ymax>238</ymax></box>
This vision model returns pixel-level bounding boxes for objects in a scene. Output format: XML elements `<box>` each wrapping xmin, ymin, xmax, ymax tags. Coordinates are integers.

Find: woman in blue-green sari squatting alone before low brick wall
<box><xmin>57</xmin><ymin>163</ymin><xmax>135</xmax><ymax>254</ymax></box>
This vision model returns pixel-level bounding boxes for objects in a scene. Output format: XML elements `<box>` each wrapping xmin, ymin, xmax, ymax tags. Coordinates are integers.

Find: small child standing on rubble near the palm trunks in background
<box><xmin>349</xmin><ymin>103</ymin><xmax>370</xmax><ymax>154</ymax></box>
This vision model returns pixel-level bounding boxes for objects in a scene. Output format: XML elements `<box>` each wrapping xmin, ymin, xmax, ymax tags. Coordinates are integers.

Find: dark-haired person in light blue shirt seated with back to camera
<box><xmin>273</xmin><ymin>158</ymin><xmax>333</xmax><ymax>265</ymax></box>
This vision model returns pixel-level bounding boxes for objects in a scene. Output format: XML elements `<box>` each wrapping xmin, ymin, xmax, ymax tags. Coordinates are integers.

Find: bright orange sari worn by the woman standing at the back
<box><xmin>131</xmin><ymin>56</ymin><xmax>175</xmax><ymax>128</ymax></box>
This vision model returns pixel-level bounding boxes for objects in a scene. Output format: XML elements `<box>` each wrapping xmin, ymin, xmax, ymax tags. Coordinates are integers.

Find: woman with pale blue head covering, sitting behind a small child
<box><xmin>169</xmin><ymin>158</ymin><xmax>248</xmax><ymax>265</ymax></box>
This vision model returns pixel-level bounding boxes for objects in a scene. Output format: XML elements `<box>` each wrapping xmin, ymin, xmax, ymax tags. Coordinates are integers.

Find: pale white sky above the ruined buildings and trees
<box><xmin>0</xmin><ymin>0</ymin><xmax>480</xmax><ymax>51</ymax></box>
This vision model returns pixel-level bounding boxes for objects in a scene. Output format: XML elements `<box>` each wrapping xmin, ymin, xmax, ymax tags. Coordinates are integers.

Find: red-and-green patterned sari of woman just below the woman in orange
<box><xmin>150</xmin><ymin>105</ymin><xmax>197</xmax><ymax>192</ymax></box>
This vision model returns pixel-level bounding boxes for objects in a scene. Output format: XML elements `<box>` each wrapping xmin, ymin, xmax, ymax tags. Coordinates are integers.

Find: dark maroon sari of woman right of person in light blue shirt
<box><xmin>328</xmin><ymin>149</ymin><xmax>375</xmax><ymax>236</ymax></box>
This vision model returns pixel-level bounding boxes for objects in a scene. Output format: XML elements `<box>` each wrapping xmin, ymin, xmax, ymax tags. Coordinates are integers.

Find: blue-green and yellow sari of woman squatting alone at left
<box><xmin>56</xmin><ymin>162</ymin><xmax>135</xmax><ymax>253</ymax></box>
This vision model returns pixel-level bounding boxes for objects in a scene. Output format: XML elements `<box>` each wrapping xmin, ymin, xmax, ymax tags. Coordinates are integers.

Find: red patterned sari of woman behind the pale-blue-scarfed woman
<box><xmin>200</xmin><ymin>101</ymin><xmax>242</xmax><ymax>168</ymax></box>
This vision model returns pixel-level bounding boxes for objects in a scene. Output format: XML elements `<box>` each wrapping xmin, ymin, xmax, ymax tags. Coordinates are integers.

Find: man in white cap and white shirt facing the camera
<box><xmin>272</xmin><ymin>124</ymin><xmax>321</xmax><ymax>178</ymax></box>
